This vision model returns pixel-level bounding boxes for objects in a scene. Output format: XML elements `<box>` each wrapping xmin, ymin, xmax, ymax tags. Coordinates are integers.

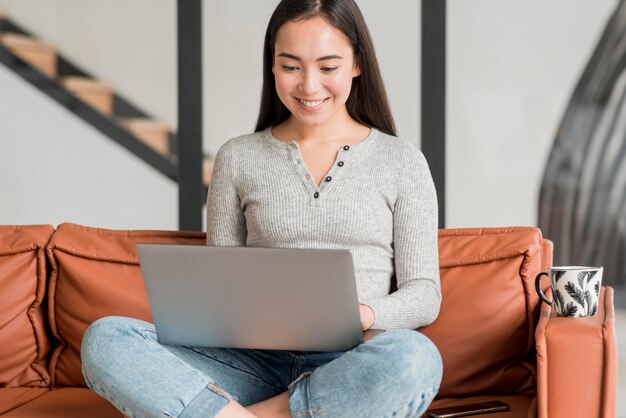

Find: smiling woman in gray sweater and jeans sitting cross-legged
<box><xmin>82</xmin><ymin>0</ymin><xmax>442</xmax><ymax>418</ymax></box>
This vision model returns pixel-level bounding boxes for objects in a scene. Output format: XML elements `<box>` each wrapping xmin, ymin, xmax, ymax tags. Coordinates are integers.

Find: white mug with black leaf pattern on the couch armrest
<box><xmin>535</xmin><ymin>266</ymin><xmax>603</xmax><ymax>317</ymax></box>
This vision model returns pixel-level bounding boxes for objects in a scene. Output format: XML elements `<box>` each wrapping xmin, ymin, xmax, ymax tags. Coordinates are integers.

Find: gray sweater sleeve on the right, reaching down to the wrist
<box><xmin>367</xmin><ymin>143</ymin><xmax>441</xmax><ymax>329</ymax></box>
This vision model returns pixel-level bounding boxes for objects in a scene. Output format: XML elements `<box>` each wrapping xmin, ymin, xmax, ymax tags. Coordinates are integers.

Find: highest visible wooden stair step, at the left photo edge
<box><xmin>0</xmin><ymin>32</ymin><xmax>58</xmax><ymax>78</ymax></box>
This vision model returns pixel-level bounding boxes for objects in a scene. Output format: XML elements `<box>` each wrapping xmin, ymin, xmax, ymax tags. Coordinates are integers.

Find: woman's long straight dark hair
<box><xmin>255</xmin><ymin>0</ymin><xmax>396</xmax><ymax>136</ymax></box>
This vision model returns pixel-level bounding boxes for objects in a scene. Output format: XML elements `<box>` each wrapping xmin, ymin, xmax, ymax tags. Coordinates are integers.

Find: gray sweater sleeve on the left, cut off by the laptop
<box><xmin>207</xmin><ymin>142</ymin><xmax>247</xmax><ymax>247</ymax></box>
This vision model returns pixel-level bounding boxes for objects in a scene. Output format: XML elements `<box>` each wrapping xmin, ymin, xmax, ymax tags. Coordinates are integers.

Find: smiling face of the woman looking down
<box><xmin>272</xmin><ymin>17</ymin><xmax>360</xmax><ymax>127</ymax></box>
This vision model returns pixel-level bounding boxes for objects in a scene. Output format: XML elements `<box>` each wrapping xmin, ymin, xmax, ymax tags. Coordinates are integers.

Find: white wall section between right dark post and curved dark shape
<box><xmin>446</xmin><ymin>0</ymin><xmax>617</xmax><ymax>227</ymax></box>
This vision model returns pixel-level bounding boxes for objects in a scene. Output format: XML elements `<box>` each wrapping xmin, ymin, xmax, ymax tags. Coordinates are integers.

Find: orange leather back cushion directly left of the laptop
<box><xmin>47</xmin><ymin>224</ymin><xmax>206</xmax><ymax>386</ymax></box>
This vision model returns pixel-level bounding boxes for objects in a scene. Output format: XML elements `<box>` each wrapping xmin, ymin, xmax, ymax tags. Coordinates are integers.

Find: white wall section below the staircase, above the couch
<box><xmin>0</xmin><ymin>65</ymin><xmax>178</xmax><ymax>229</ymax></box>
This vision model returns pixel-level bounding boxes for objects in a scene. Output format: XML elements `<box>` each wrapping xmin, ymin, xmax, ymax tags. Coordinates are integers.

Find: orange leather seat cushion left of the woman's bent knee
<box><xmin>2</xmin><ymin>388</ymin><xmax>124</xmax><ymax>418</ymax></box>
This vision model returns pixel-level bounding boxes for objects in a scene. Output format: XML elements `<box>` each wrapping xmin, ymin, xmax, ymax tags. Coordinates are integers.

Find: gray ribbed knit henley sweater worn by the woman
<box><xmin>207</xmin><ymin>129</ymin><xmax>441</xmax><ymax>329</ymax></box>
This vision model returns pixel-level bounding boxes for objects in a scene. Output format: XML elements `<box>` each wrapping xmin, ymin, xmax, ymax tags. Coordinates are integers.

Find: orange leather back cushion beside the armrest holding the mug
<box><xmin>420</xmin><ymin>227</ymin><xmax>543</xmax><ymax>398</ymax></box>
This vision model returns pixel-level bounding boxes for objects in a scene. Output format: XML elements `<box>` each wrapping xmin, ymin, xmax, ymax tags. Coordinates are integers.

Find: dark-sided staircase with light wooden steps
<box><xmin>0</xmin><ymin>9</ymin><xmax>213</xmax><ymax>193</ymax></box>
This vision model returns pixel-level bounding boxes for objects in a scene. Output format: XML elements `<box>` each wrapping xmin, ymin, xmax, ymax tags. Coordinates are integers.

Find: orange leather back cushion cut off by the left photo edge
<box><xmin>0</xmin><ymin>225</ymin><xmax>54</xmax><ymax>387</ymax></box>
